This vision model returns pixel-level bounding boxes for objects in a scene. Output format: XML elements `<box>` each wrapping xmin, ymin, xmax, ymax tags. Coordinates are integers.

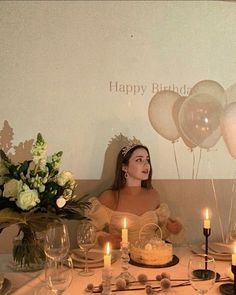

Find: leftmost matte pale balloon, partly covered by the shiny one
<box><xmin>148</xmin><ymin>90</ymin><xmax>180</xmax><ymax>141</ymax></box>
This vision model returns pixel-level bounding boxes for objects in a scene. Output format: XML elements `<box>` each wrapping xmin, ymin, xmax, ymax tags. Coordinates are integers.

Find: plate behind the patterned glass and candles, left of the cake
<box><xmin>71</xmin><ymin>249</ymin><xmax>119</xmax><ymax>268</ymax></box>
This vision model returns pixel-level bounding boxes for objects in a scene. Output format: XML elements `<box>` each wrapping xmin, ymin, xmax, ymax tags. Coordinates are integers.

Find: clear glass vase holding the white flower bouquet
<box><xmin>13</xmin><ymin>225</ymin><xmax>45</xmax><ymax>271</ymax></box>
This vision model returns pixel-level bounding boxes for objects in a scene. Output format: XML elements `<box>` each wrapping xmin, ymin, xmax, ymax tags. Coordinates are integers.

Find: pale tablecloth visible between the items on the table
<box><xmin>0</xmin><ymin>247</ymin><xmax>230</xmax><ymax>295</ymax></box>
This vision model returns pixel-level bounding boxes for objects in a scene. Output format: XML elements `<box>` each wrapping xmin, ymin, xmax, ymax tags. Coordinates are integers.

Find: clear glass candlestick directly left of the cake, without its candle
<box><xmin>116</xmin><ymin>242</ymin><xmax>135</xmax><ymax>282</ymax></box>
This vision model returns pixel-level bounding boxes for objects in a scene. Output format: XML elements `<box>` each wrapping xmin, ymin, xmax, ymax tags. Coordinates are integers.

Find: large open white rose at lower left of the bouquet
<box><xmin>16</xmin><ymin>189</ymin><xmax>40</xmax><ymax>210</ymax></box>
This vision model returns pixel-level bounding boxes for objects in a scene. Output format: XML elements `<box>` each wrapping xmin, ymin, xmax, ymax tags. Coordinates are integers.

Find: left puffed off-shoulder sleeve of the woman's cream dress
<box><xmin>86</xmin><ymin>197</ymin><xmax>112</xmax><ymax>231</ymax></box>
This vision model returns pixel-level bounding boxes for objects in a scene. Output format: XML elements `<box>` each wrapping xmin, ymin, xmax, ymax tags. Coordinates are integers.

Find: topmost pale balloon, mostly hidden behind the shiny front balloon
<box><xmin>189</xmin><ymin>80</ymin><xmax>226</xmax><ymax>107</ymax></box>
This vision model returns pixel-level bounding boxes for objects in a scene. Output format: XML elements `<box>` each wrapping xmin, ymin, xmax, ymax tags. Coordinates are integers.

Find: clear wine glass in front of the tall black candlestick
<box><xmin>188</xmin><ymin>254</ymin><xmax>216</xmax><ymax>294</ymax></box>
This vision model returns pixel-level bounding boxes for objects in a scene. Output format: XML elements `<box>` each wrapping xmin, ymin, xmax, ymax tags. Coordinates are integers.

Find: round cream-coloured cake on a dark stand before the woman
<box><xmin>130</xmin><ymin>237</ymin><xmax>173</xmax><ymax>266</ymax></box>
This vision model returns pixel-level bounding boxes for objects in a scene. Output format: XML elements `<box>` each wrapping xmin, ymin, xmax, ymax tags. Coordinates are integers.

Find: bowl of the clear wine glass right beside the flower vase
<box><xmin>44</xmin><ymin>221</ymin><xmax>70</xmax><ymax>261</ymax></box>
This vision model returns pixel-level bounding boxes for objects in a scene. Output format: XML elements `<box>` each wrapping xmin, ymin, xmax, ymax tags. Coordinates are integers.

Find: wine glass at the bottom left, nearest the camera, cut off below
<box><xmin>45</xmin><ymin>257</ymin><xmax>73</xmax><ymax>295</ymax></box>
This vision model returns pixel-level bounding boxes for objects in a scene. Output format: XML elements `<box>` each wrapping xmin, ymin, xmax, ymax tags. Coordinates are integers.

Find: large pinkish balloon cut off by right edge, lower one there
<box><xmin>220</xmin><ymin>102</ymin><xmax>236</xmax><ymax>159</ymax></box>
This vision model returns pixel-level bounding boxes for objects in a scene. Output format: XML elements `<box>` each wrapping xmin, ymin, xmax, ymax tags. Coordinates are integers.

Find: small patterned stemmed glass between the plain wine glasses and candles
<box><xmin>77</xmin><ymin>221</ymin><xmax>96</xmax><ymax>276</ymax></box>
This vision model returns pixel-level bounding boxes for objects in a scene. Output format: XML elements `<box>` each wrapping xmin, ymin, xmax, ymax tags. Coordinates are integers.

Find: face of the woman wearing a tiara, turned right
<box><xmin>123</xmin><ymin>148</ymin><xmax>151</xmax><ymax>181</ymax></box>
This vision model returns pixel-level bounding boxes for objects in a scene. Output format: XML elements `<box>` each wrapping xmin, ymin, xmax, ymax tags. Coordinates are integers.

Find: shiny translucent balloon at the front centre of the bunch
<box><xmin>179</xmin><ymin>94</ymin><xmax>223</xmax><ymax>149</ymax></box>
